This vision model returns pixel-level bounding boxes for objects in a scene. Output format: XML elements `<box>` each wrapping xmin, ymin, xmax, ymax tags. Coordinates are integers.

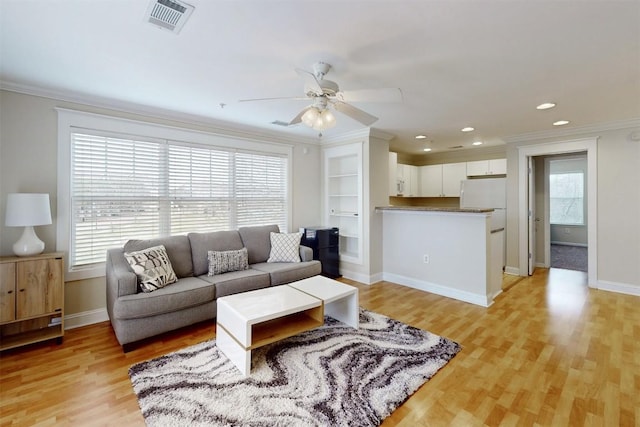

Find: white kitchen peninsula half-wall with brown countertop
<box><xmin>375</xmin><ymin>206</ymin><xmax>504</xmax><ymax>307</ymax></box>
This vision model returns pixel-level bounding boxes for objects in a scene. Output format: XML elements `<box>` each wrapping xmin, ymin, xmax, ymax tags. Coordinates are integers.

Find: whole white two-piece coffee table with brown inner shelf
<box><xmin>216</xmin><ymin>276</ymin><xmax>359</xmax><ymax>376</ymax></box>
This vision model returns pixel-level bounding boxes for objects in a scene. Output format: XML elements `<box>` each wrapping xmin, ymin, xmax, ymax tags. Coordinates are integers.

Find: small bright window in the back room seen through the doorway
<box><xmin>549</xmin><ymin>172</ymin><xmax>585</xmax><ymax>225</ymax></box>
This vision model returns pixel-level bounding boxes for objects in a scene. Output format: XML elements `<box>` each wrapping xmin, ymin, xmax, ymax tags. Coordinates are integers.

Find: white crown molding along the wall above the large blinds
<box><xmin>0</xmin><ymin>80</ymin><xmax>322</xmax><ymax>145</ymax></box>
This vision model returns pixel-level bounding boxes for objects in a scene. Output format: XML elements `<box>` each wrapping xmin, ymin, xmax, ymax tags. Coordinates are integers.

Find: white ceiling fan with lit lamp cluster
<box><xmin>240</xmin><ymin>62</ymin><xmax>402</xmax><ymax>131</ymax></box>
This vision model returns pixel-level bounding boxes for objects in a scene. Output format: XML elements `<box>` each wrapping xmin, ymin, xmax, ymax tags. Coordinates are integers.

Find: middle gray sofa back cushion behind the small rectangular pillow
<box><xmin>187</xmin><ymin>230</ymin><xmax>243</xmax><ymax>276</ymax></box>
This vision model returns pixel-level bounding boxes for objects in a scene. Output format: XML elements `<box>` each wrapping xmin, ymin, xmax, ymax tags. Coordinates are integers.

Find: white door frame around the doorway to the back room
<box><xmin>518</xmin><ymin>138</ymin><xmax>598</xmax><ymax>286</ymax></box>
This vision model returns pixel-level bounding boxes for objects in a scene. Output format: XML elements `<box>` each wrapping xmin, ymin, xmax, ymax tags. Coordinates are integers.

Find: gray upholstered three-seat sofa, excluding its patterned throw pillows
<box><xmin>106</xmin><ymin>225</ymin><xmax>321</xmax><ymax>351</ymax></box>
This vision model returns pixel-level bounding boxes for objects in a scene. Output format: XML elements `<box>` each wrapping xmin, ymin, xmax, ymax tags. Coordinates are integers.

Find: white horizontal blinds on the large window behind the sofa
<box><xmin>69</xmin><ymin>131</ymin><xmax>288</xmax><ymax>269</ymax></box>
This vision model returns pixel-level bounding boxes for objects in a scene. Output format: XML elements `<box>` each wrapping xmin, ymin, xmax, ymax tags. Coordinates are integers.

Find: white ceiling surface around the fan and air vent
<box><xmin>0</xmin><ymin>0</ymin><xmax>640</xmax><ymax>153</ymax></box>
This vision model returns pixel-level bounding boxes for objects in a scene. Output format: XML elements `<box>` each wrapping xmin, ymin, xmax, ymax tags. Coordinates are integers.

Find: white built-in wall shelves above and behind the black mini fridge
<box><xmin>324</xmin><ymin>143</ymin><xmax>362</xmax><ymax>263</ymax></box>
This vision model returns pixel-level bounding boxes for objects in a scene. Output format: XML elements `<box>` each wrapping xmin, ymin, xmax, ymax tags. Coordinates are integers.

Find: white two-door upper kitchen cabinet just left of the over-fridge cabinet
<box><xmin>420</xmin><ymin>163</ymin><xmax>467</xmax><ymax>197</ymax></box>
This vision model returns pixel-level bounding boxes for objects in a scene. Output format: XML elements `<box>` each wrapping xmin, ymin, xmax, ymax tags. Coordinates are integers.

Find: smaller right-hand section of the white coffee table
<box><xmin>289</xmin><ymin>276</ymin><xmax>360</xmax><ymax>329</ymax></box>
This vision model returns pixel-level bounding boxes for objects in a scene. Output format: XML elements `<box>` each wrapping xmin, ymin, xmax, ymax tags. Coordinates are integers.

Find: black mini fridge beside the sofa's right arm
<box><xmin>300</xmin><ymin>227</ymin><xmax>340</xmax><ymax>279</ymax></box>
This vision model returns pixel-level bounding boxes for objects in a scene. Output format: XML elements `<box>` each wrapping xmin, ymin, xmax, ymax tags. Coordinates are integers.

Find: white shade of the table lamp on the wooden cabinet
<box><xmin>5</xmin><ymin>193</ymin><xmax>51</xmax><ymax>227</ymax></box>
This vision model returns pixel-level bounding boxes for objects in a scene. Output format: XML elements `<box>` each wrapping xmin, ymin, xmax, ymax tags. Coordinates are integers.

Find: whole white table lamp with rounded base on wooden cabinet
<box><xmin>5</xmin><ymin>193</ymin><xmax>51</xmax><ymax>256</ymax></box>
